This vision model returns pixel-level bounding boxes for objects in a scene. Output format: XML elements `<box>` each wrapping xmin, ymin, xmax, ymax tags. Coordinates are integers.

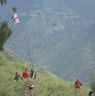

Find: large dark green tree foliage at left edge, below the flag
<box><xmin>0</xmin><ymin>21</ymin><xmax>12</xmax><ymax>51</ymax></box>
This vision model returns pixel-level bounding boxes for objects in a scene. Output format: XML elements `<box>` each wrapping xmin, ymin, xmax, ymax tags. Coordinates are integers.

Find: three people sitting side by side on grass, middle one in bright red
<box><xmin>15</xmin><ymin>69</ymin><xmax>36</xmax><ymax>81</ymax></box>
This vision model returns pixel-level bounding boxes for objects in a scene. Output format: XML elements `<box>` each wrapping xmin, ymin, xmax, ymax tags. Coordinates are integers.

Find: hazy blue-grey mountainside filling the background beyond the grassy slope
<box><xmin>3</xmin><ymin>0</ymin><xmax>95</xmax><ymax>81</ymax></box>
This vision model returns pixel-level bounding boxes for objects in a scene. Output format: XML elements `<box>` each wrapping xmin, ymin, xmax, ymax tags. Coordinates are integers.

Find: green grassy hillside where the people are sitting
<box><xmin>0</xmin><ymin>50</ymin><xmax>89</xmax><ymax>96</ymax></box>
